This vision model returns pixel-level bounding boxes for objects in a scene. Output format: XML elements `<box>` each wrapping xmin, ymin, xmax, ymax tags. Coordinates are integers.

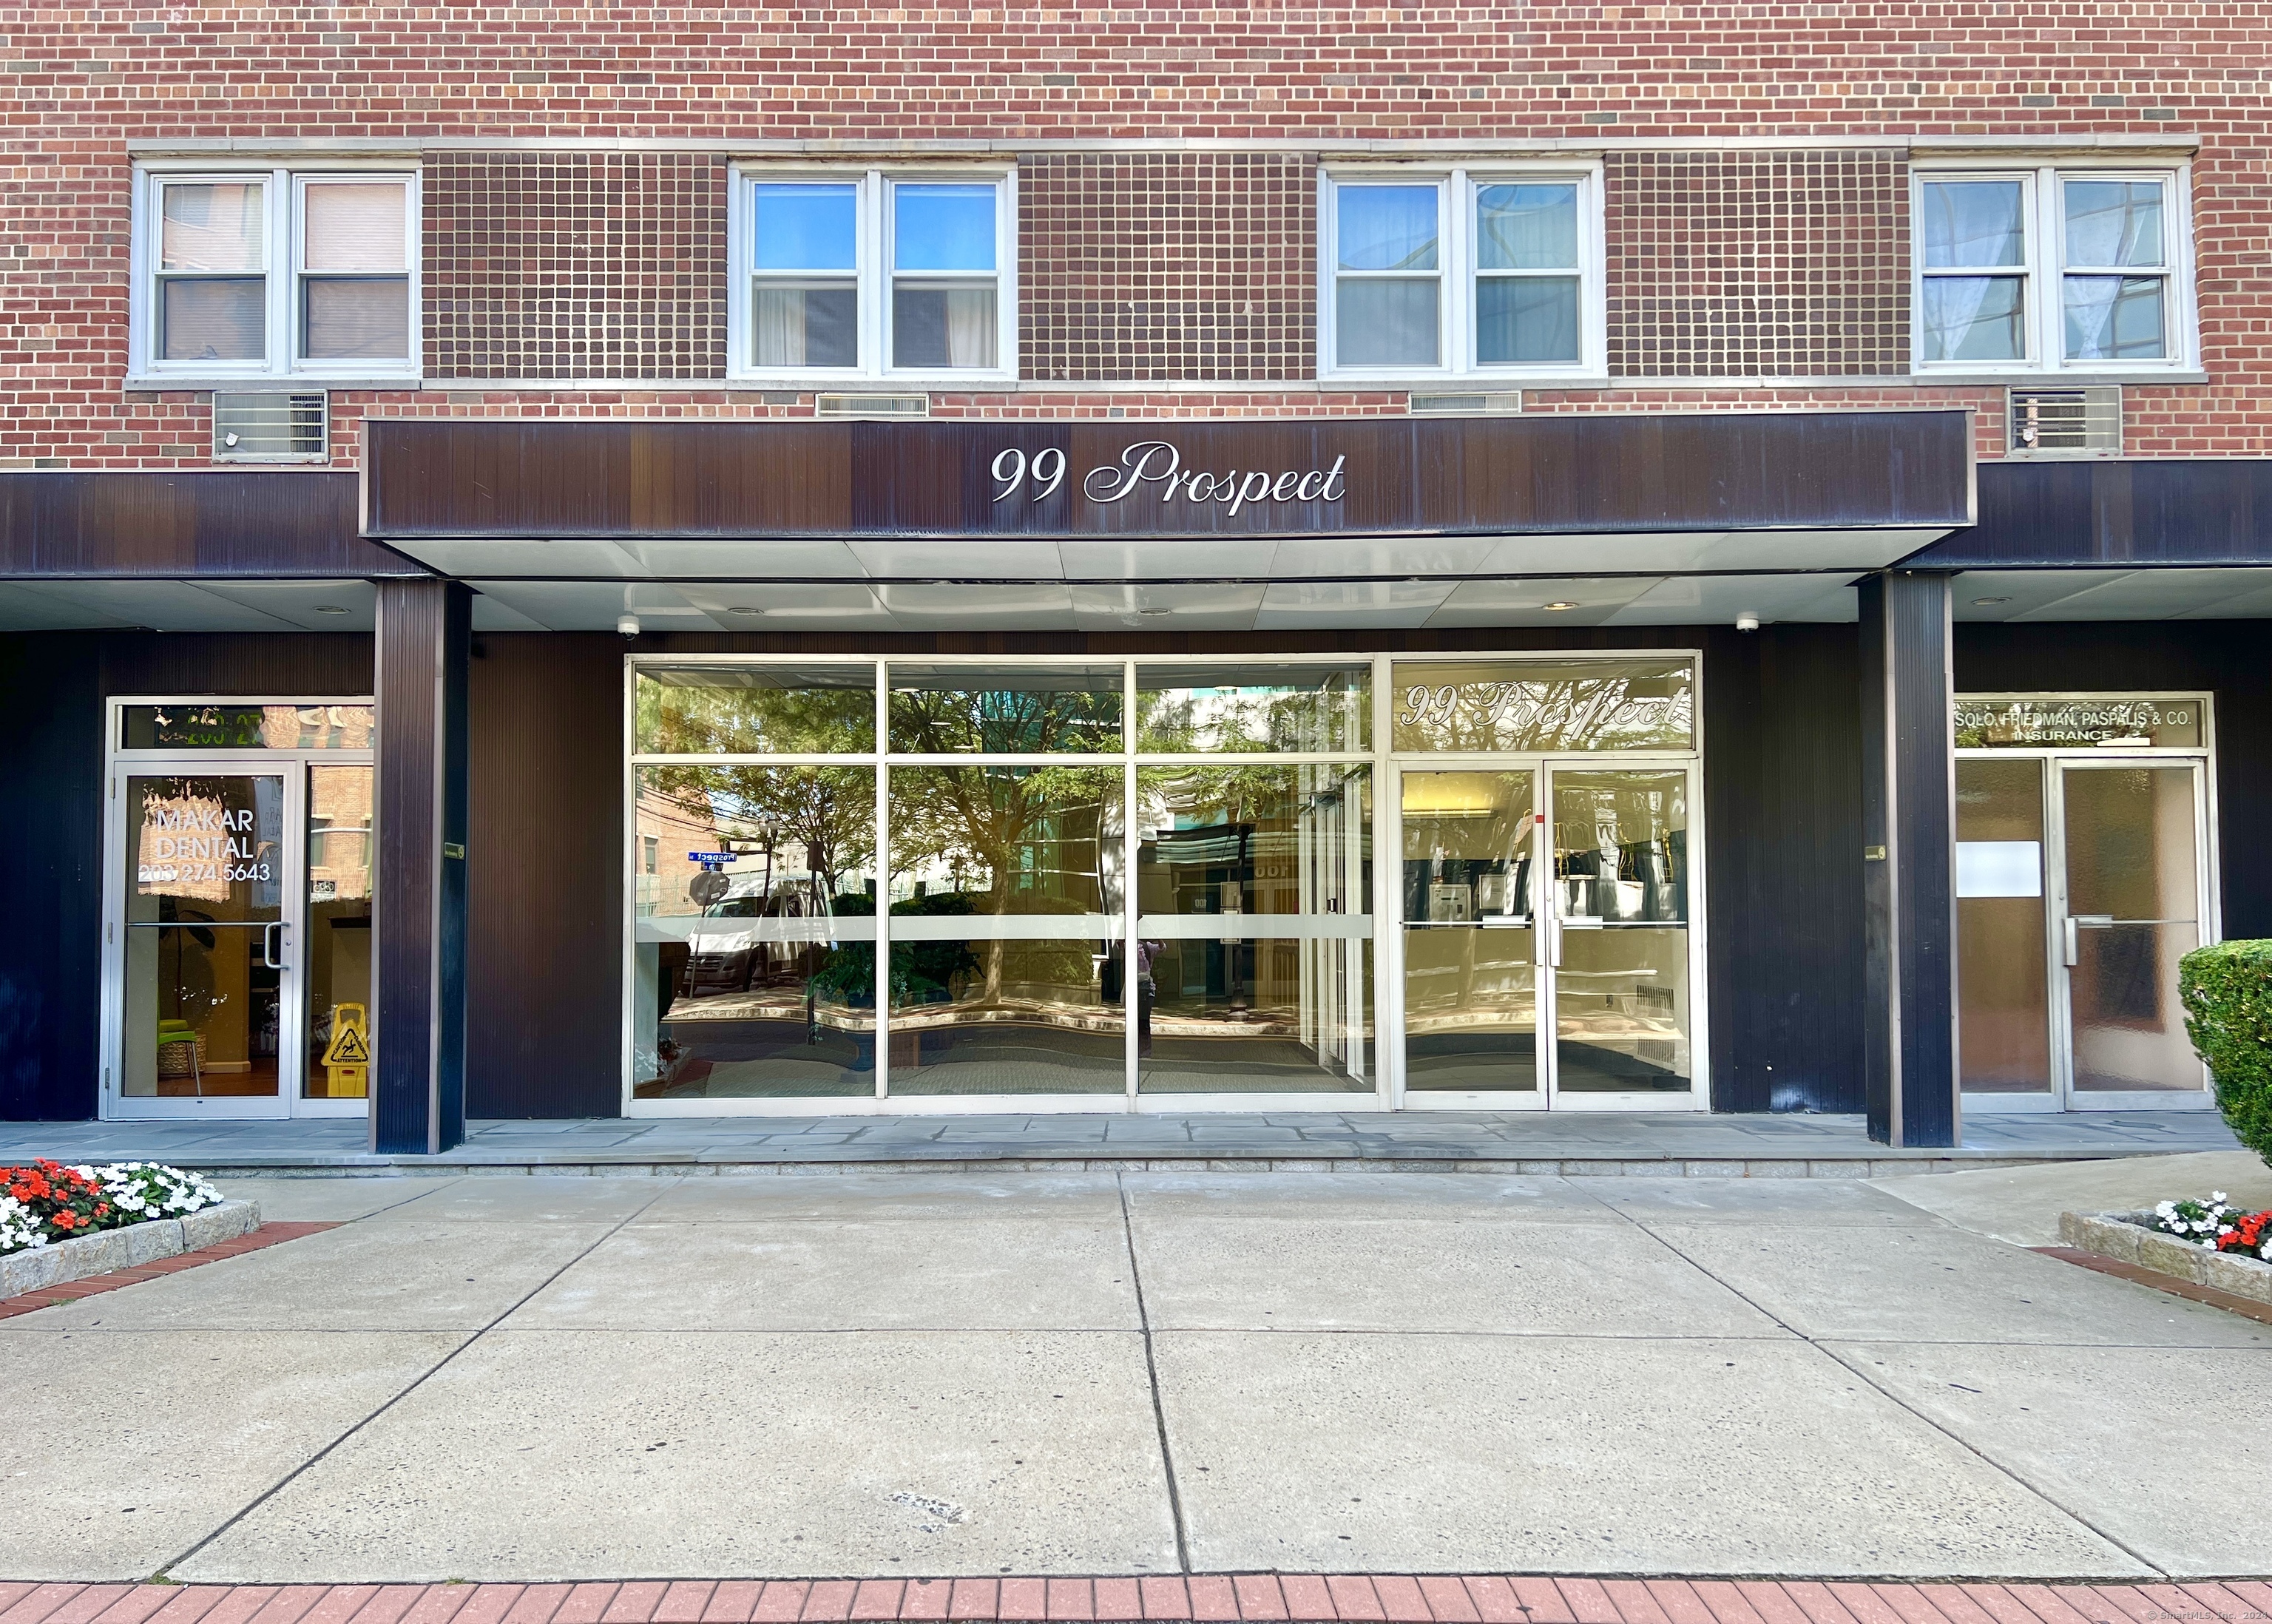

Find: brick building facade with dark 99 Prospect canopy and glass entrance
<box><xmin>0</xmin><ymin>4</ymin><xmax>2272</xmax><ymax>1151</ymax></box>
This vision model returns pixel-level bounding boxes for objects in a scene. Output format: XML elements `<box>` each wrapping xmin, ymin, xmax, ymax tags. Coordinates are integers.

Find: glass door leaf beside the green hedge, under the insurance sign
<box><xmin>2058</xmin><ymin>761</ymin><xmax>2206</xmax><ymax>1106</ymax></box>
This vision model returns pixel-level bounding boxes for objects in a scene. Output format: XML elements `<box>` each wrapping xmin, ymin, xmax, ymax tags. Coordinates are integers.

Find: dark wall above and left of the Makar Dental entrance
<box><xmin>0</xmin><ymin>632</ymin><xmax>371</xmax><ymax>1122</ymax></box>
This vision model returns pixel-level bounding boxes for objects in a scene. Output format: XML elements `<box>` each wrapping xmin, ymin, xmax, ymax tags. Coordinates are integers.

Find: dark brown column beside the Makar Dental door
<box><xmin>371</xmin><ymin>579</ymin><xmax>473</xmax><ymax>1156</ymax></box>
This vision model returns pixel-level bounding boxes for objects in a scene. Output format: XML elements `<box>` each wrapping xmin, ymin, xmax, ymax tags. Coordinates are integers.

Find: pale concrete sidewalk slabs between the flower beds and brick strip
<box><xmin>0</xmin><ymin>1172</ymin><xmax>2272</xmax><ymax>1580</ymax></box>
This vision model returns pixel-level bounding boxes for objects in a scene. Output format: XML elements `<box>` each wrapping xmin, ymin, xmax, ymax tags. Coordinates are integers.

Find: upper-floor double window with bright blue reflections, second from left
<box><xmin>731</xmin><ymin>170</ymin><xmax>1015</xmax><ymax>377</ymax></box>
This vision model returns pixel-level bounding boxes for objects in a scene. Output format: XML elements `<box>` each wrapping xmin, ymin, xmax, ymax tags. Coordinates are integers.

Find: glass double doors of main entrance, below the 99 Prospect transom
<box><xmin>1399</xmin><ymin>763</ymin><xmax>1695</xmax><ymax>1109</ymax></box>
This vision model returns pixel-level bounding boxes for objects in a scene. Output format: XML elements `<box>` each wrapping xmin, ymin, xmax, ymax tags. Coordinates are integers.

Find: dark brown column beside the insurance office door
<box><xmin>1859</xmin><ymin>570</ymin><xmax>1963</xmax><ymax>1145</ymax></box>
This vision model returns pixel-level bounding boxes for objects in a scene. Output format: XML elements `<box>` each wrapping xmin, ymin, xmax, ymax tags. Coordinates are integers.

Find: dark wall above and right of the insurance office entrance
<box><xmin>1956</xmin><ymin>620</ymin><xmax>2272</xmax><ymax>936</ymax></box>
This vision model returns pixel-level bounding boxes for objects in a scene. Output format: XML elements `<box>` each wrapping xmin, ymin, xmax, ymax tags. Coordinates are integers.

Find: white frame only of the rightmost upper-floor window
<box><xmin>1908</xmin><ymin>159</ymin><xmax>2202</xmax><ymax>382</ymax></box>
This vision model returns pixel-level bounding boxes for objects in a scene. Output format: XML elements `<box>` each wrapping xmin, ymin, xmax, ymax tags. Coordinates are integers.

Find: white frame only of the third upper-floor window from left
<box><xmin>1318</xmin><ymin>159</ymin><xmax>1609</xmax><ymax>386</ymax></box>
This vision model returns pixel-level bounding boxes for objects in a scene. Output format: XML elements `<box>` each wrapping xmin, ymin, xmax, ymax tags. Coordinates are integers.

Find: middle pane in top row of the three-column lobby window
<box><xmin>890</xmin><ymin>661</ymin><xmax>1125</xmax><ymax>757</ymax></box>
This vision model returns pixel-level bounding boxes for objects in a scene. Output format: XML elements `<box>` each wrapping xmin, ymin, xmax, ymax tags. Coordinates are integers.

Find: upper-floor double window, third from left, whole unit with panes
<box><xmin>1318</xmin><ymin>170</ymin><xmax>1604</xmax><ymax>377</ymax></box>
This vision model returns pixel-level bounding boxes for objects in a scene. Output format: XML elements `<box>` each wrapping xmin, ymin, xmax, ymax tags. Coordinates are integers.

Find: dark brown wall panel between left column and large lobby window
<box><xmin>466</xmin><ymin>632</ymin><xmax>625</xmax><ymax>1117</ymax></box>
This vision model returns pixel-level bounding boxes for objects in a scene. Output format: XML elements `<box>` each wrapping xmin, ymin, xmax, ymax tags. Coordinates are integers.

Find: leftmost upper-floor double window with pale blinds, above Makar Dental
<box><xmin>134</xmin><ymin>168</ymin><xmax>418</xmax><ymax>382</ymax></box>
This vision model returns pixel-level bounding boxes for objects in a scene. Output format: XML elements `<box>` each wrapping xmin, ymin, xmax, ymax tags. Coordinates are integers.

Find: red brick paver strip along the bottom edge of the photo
<box><xmin>0</xmin><ymin>1574</ymin><xmax>2272</xmax><ymax>1624</ymax></box>
